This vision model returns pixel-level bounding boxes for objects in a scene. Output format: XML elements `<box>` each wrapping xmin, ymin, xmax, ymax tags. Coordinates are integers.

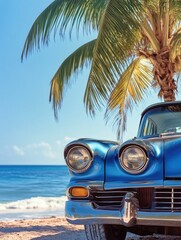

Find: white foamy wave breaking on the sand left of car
<box><xmin>0</xmin><ymin>196</ymin><xmax>67</xmax><ymax>211</ymax></box>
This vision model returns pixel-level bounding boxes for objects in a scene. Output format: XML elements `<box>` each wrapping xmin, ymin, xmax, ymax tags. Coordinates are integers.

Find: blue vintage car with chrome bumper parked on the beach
<box><xmin>65</xmin><ymin>102</ymin><xmax>181</xmax><ymax>240</ymax></box>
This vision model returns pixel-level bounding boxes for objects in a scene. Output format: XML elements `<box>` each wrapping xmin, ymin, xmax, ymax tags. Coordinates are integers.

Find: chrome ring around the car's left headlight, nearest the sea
<box><xmin>64</xmin><ymin>145</ymin><xmax>93</xmax><ymax>173</ymax></box>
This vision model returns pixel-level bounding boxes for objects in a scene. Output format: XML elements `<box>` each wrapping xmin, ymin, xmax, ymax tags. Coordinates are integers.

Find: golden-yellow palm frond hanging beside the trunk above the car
<box><xmin>105</xmin><ymin>57</ymin><xmax>153</xmax><ymax>139</ymax></box>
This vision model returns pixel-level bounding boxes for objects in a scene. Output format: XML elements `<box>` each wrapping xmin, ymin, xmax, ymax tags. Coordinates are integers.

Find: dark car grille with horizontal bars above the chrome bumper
<box><xmin>90</xmin><ymin>188</ymin><xmax>181</xmax><ymax>212</ymax></box>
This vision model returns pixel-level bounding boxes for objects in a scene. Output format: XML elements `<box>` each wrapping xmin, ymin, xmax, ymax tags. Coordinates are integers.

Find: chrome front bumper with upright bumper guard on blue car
<box><xmin>65</xmin><ymin>192</ymin><xmax>181</xmax><ymax>227</ymax></box>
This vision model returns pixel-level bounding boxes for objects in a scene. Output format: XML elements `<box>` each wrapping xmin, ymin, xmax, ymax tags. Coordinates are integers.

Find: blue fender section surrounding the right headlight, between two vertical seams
<box><xmin>104</xmin><ymin>138</ymin><xmax>163</xmax><ymax>189</ymax></box>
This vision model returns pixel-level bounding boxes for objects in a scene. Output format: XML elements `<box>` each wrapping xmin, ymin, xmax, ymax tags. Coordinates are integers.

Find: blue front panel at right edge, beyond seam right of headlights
<box><xmin>164</xmin><ymin>136</ymin><xmax>181</xmax><ymax>179</ymax></box>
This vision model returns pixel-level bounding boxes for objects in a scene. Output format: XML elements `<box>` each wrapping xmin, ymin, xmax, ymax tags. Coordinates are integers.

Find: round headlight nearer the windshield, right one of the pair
<box><xmin>119</xmin><ymin>146</ymin><xmax>148</xmax><ymax>174</ymax></box>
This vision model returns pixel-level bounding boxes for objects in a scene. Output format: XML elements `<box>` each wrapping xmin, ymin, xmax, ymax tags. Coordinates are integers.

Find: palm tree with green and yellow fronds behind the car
<box><xmin>22</xmin><ymin>0</ymin><xmax>181</xmax><ymax>138</ymax></box>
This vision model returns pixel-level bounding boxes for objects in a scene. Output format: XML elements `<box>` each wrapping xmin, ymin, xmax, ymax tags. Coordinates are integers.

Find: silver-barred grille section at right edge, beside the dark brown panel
<box><xmin>154</xmin><ymin>188</ymin><xmax>181</xmax><ymax>212</ymax></box>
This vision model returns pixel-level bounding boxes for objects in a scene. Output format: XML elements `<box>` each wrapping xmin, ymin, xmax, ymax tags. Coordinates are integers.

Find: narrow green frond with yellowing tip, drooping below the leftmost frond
<box><xmin>49</xmin><ymin>39</ymin><xmax>96</xmax><ymax>118</ymax></box>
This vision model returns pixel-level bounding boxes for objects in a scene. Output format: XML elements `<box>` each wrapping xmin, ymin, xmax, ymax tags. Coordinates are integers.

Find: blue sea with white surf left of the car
<box><xmin>0</xmin><ymin>166</ymin><xmax>69</xmax><ymax>220</ymax></box>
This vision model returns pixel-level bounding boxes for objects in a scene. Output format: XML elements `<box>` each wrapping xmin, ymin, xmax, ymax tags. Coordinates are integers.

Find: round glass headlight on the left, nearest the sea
<box><xmin>66</xmin><ymin>146</ymin><xmax>92</xmax><ymax>173</ymax></box>
